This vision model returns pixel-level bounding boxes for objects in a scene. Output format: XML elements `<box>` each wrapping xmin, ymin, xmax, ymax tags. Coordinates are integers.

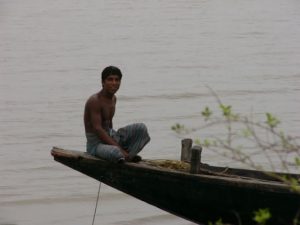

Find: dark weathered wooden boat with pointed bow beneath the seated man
<box><xmin>51</xmin><ymin>143</ymin><xmax>300</xmax><ymax>225</ymax></box>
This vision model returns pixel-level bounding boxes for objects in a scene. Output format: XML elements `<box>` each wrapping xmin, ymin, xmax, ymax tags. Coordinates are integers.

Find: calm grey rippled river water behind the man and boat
<box><xmin>0</xmin><ymin>0</ymin><xmax>300</xmax><ymax>225</ymax></box>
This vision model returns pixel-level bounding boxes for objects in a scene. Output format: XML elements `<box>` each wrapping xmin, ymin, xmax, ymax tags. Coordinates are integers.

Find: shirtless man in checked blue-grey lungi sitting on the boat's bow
<box><xmin>84</xmin><ymin>66</ymin><xmax>150</xmax><ymax>162</ymax></box>
